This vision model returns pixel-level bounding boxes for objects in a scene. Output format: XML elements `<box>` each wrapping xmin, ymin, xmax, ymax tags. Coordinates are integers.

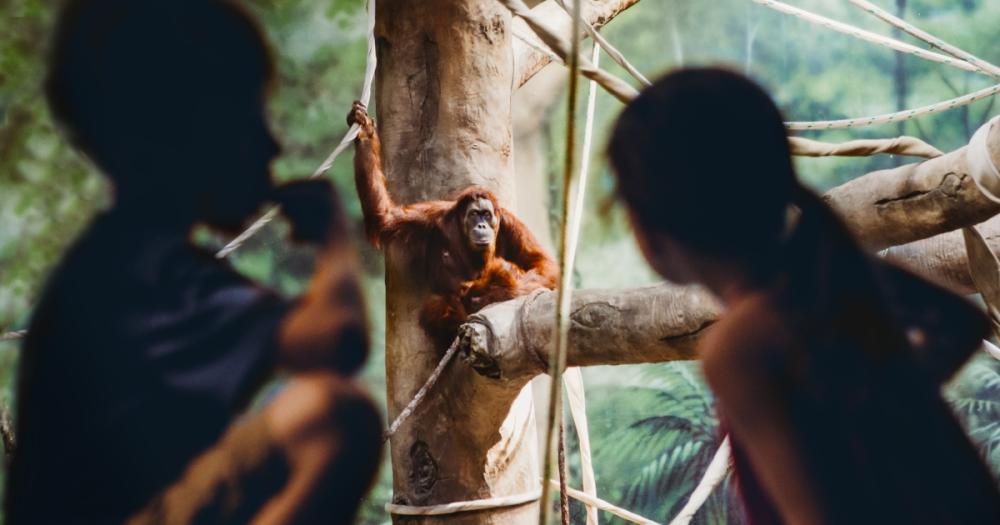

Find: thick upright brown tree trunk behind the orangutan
<box><xmin>375</xmin><ymin>0</ymin><xmax>637</xmax><ymax>525</ymax></box>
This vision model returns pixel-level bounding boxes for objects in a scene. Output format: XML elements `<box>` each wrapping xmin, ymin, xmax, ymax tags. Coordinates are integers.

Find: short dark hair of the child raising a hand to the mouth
<box><xmin>45</xmin><ymin>0</ymin><xmax>273</xmax><ymax>194</ymax></box>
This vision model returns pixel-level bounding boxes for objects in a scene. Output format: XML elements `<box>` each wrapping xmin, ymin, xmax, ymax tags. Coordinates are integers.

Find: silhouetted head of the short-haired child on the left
<box><xmin>46</xmin><ymin>0</ymin><xmax>278</xmax><ymax>227</ymax></box>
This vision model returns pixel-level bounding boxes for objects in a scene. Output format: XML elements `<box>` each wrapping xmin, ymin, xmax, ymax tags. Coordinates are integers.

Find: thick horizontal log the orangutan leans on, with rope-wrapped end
<box><xmin>459</xmin><ymin>284</ymin><xmax>718</xmax><ymax>382</ymax></box>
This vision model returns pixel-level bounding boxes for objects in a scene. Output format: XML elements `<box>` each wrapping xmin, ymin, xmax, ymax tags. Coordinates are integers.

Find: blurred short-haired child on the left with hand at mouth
<box><xmin>7</xmin><ymin>0</ymin><xmax>380</xmax><ymax>524</ymax></box>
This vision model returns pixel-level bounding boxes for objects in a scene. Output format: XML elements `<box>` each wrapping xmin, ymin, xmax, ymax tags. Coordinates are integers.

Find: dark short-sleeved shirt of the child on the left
<box><xmin>7</xmin><ymin>212</ymin><xmax>288</xmax><ymax>524</ymax></box>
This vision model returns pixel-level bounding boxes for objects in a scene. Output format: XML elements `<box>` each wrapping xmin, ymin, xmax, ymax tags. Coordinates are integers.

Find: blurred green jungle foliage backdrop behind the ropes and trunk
<box><xmin>0</xmin><ymin>0</ymin><xmax>1000</xmax><ymax>525</ymax></box>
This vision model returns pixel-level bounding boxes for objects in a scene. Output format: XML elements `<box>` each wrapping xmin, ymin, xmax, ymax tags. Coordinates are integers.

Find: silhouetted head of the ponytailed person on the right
<box><xmin>609</xmin><ymin>69</ymin><xmax>799</xmax><ymax>281</ymax></box>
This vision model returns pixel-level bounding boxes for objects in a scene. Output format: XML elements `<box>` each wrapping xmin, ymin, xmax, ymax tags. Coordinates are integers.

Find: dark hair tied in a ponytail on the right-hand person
<box><xmin>609</xmin><ymin>68</ymin><xmax>872</xmax><ymax>303</ymax></box>
